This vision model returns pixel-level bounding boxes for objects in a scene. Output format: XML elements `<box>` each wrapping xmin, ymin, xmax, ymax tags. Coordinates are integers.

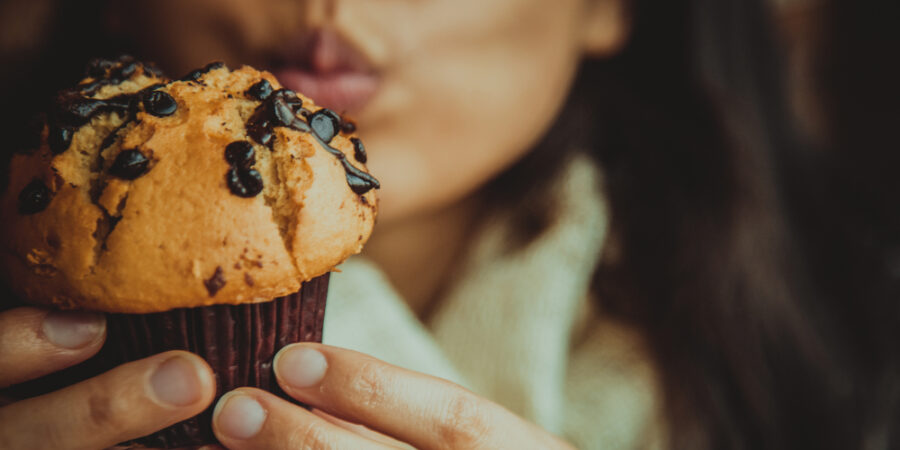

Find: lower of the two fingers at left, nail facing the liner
<box><xmin>0</xmin><ymin>351</ymin><xmax>215</xmax><ymax>449</ymax></box>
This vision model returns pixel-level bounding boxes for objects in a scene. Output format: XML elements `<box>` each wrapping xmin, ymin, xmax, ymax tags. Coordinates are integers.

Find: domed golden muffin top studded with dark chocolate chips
<box><xmin>0</xmin><ymin>57</ymin><xmax>379</xmax><ymax>313</ymax></box>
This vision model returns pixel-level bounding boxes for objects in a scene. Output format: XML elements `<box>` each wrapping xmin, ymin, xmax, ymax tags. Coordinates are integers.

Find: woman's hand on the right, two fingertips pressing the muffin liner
<box><xmin>213</xmin><ymin>344</ymin><xmax>569</xmax><ymax>449</ymax></box>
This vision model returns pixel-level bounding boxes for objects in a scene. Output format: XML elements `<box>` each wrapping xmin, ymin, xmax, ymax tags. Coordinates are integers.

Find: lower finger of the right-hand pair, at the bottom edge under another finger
<box><xmin>213</xmin><ymin>388</ymin><xmax>392</xmax><ymax>450</ymax></box>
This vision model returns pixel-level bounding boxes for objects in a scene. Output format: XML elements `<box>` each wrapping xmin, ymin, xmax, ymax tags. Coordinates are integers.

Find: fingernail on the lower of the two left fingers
<box><xmin>150</xmin><ymin>356</ymin><xmax>203</xmax><ymax>406</ymax></box>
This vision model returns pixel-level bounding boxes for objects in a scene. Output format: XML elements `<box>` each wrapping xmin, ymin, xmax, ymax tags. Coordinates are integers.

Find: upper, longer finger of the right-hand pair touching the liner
<box><xmin>274</xmin><ymin>344</ymin><xmax>565</xmax><ymax>448</ymax></box>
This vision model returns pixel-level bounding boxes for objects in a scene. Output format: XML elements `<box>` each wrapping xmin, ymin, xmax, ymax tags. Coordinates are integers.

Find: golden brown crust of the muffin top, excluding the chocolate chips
<box><xmin>0</xmin><ymin>62</ymin><xmax>376</xmax><ymax>313</ymax></box>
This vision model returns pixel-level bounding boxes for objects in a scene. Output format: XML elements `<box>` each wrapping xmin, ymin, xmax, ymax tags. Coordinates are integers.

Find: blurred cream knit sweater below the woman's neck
<box><xmin>324</xmin><ymin>157</ymin><xmax>665</xmax><ymax>449</ymax></box>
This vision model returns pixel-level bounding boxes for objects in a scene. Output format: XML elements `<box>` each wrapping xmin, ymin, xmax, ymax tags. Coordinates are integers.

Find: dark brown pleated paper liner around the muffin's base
<box><xmin>17</xmin><ymin>273</ymin><xmax>329</xmax><ymax>448</ymax></box>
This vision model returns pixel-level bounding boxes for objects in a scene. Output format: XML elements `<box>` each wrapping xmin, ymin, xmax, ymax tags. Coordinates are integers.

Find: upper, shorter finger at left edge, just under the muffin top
<box><xmin>0</xmin><ymin>308</ymin><xmax>106</xmax><ymax>388</ymax></box>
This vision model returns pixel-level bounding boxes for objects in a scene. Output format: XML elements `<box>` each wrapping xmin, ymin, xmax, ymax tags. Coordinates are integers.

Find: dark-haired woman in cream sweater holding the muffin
<box><xmin>0</xmin><ymin>0</ymin><xmax>897</xmax><ymax>448</ymax></box>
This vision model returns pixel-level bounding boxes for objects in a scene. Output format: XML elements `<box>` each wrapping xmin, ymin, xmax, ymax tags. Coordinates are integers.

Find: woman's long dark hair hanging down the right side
<box><xmin>591</xmin><ymin>0</ymin><xmax>900</xmax><ymax>449</ymax></box>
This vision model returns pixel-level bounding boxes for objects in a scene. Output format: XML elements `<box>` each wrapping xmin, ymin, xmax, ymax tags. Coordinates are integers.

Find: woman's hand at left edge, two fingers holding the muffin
<box><xmin>0</xmin><ymin>308</ymin><xmax>215</xmax><ymax>449</ymax></box>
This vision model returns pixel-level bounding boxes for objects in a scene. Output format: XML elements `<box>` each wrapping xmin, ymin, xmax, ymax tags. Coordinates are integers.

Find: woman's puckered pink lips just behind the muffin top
<box><xmin>272</xmin><ymin>29</ymin><xmax>379</xmax><ymax>114</ymax></box>
